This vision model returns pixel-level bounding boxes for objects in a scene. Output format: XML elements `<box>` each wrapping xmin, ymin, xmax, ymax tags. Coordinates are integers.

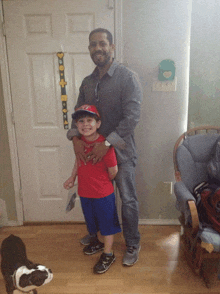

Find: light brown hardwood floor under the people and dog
<box><xmin>0</xmin><ymin>224</ymin><xmax>220</xmax><ymax>294</ymax></box>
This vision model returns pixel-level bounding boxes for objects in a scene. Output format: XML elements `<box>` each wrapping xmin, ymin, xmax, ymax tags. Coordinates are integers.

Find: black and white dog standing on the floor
<box><xmin>1</xmin><ymin>235</ymin><xmax>53</xmax><ymax>294</ymax></box>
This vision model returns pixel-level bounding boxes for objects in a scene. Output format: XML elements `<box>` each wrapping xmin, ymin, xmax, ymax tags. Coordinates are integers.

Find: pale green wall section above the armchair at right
<box><xmin>188</xmin><ymin>0</ymin><xmax>220</xmax><ymax>128</ymax></box>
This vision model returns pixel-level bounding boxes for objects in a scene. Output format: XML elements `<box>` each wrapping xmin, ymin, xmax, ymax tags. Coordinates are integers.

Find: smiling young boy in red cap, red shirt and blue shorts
<box><xmin>64</xmin><ymin>105</ymin><xmax>121</xmax><ymax>274</ymax></box>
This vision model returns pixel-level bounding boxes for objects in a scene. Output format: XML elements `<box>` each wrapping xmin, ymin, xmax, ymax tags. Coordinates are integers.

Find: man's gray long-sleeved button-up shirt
<box><xmin>67</xmin><ymin>60</ymin><xmax>142</xmax><ymax>164</ymax></box>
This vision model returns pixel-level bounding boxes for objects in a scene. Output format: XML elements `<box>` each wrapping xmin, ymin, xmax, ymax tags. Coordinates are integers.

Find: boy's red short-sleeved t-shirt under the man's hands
<box><xmin>78</xmin><ymin>135</ymin><xmax>117</xmax><ymax>198</ymax></box>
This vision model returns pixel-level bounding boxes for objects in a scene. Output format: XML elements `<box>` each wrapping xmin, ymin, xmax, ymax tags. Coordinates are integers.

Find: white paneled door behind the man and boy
<box><xmin>3</xmin><ymin>0</ymin><xmax>114</xmax><ymax>221</ymax></box>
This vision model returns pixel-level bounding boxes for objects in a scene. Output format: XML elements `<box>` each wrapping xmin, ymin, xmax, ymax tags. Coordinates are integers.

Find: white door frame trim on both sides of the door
<box><xmin>0</xmin><ymin>0</ymin><xmax>123</xmax><ymax>226</ymax></box>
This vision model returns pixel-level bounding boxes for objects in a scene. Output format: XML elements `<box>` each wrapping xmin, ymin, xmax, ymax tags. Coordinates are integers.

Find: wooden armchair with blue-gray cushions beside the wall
<box><xmin>173</xmin><ymin>126</ymin><xmax>220</xmax><ymax>287</ymax></box>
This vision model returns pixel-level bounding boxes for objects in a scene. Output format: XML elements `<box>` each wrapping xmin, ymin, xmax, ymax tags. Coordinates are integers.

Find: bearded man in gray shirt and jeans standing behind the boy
<box><xmin>67</xmin><ymin>28</ymin><xmax>142</xmax><ymax>266</ymax></box>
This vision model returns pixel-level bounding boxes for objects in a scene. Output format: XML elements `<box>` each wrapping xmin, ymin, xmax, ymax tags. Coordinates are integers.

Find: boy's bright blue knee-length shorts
<box><xmin>80</xmin><ymin>193</ymin><xmax>121</xmax><ymax>236</ymax></box>
